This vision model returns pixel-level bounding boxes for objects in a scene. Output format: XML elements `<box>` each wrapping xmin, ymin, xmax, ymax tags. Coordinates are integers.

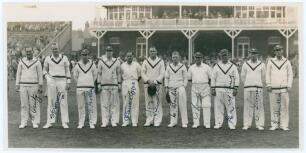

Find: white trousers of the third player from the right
<box><xmin>214</xmin><ymin>89</ymin><xmax>237</xmax><ymax>128</ymax></box>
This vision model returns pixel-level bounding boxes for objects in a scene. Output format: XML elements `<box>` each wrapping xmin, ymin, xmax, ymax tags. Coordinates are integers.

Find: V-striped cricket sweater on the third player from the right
<box><xmin>211</xmin><ymin>61</ymin><xmax>239</xmax><ymax>91</ymax></box>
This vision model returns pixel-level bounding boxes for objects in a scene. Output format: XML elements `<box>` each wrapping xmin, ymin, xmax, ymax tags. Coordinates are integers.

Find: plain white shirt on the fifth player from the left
<box><xmin>121</xmin><ymin>61</ymin><xmax>141</xmax><ymax>81</ymax></box>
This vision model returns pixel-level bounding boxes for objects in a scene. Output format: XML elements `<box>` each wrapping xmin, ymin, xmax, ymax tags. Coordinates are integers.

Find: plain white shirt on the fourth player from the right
<box><xmin>188</xmin><ymin>63</ymin><xmax>211</xmax><ymax>83</ymax></box>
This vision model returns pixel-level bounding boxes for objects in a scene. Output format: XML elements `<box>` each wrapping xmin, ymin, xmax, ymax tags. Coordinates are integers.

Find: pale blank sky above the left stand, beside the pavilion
<box><xmin>3</xmin><ymin>2</ymin><xmax>106</xmax><ymax>30</ymax></box>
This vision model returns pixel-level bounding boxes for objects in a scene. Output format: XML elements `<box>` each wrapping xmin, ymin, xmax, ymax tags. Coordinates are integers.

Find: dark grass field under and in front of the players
<box><xmin>8</xmin><ymin>79</ymin><xmax>299</xmax><ymax>148</ymax></box>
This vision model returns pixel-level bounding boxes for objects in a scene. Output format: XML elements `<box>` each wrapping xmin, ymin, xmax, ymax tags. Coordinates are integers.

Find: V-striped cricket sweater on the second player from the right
<box><xmin>241</xmin><ymin>60</ymin><xmax>266</xmax><ymax>89</ymax></box>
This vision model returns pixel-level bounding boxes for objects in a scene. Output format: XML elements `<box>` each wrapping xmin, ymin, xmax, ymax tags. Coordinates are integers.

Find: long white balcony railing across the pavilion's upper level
<box><xmin>90</xmin><ymin>18</ymin><xmax>297</xmax><ymax>30</ymax></box>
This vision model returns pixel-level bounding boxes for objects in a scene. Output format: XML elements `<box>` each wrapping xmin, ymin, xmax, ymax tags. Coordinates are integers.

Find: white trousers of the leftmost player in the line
<box><xmin>20</xmin><ymin>85</ymin><xmax>42</xmax><ymax>125</ymax></box>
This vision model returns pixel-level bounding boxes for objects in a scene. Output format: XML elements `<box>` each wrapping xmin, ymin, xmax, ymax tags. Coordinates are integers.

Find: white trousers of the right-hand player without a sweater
<box><xmin>191</xmin><ymin>83</ymin><xmax>211</xmax><ymax>127</ymax></box>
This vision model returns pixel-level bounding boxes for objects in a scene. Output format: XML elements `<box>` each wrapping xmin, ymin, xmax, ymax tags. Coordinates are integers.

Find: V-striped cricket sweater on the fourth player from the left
<box><xmin>98</xmin><ymin>57</ymin><xmax>121</xmax><ymax>86</ymax></box>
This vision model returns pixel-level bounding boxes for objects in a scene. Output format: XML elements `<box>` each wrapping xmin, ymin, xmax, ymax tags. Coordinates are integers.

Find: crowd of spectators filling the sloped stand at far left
<box><xmin>7</xmin><ymin>22</ymin><xmax>67</xmax><ymax>79</ymax></box>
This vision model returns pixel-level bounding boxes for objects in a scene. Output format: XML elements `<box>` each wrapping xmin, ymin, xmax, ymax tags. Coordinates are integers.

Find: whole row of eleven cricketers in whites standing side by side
<box><xmin>16</xmin><ymin>44</ymin><xmax>293</xmax><ymax>130</ymax></box>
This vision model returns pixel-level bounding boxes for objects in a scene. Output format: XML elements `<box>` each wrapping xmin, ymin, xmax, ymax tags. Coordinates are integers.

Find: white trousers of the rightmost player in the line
<box><xmin>269</xmin><ymin>91</ymin><xmax>289</xmax><ymax>128</ymax></box>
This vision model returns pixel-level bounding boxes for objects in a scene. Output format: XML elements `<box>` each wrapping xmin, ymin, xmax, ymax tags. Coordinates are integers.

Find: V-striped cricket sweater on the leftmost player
<box><xmin>16</xmin><ymin>57</ymin><xmax>43</xmax><ymax>86</ymax></box>
